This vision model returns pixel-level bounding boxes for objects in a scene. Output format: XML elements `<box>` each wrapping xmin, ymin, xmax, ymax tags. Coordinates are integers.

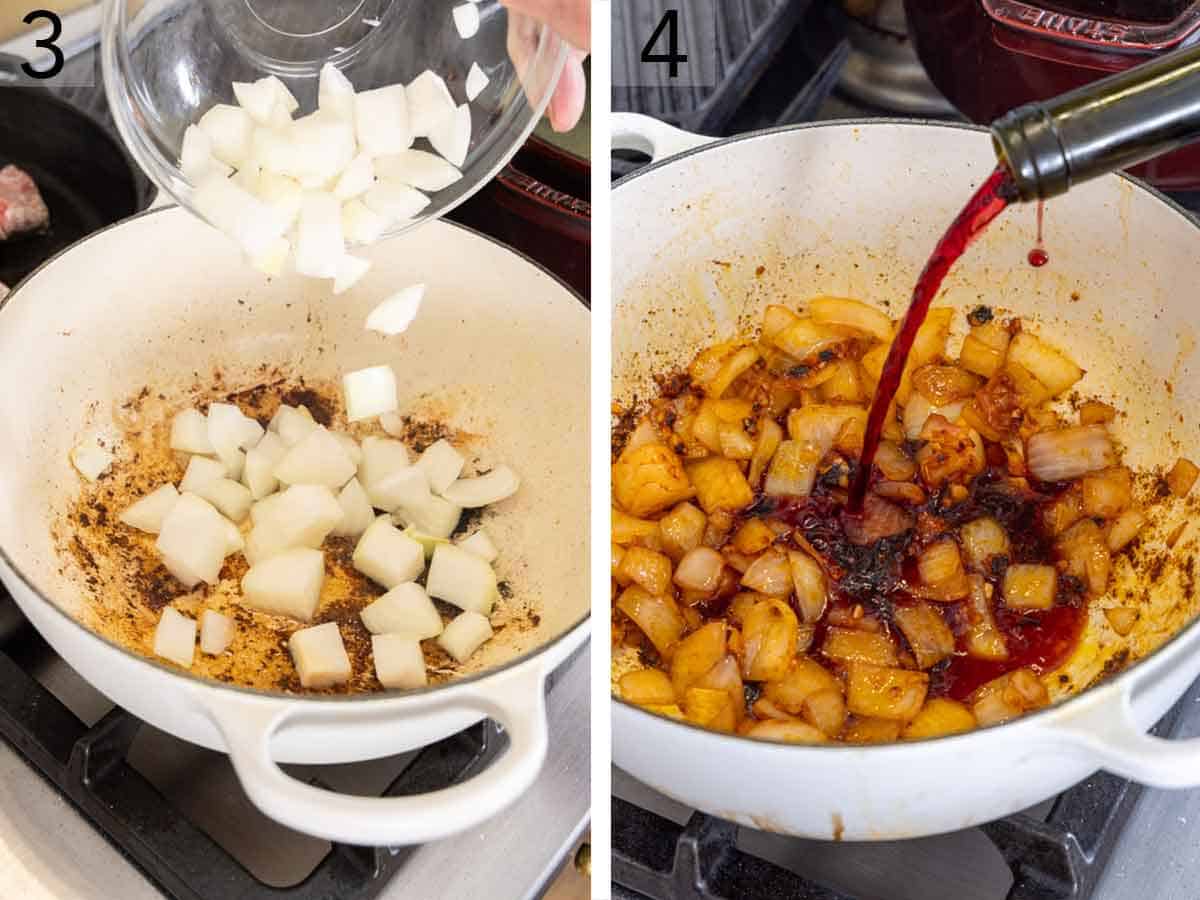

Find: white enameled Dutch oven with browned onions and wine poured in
<box><xmin>613</xmin><ymin>115</ymin><xmax>1200</xmax><ymax>840</ymax></box>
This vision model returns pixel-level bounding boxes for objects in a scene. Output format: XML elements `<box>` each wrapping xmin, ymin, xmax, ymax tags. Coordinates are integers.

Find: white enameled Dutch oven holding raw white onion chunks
<box><xmin>0</xmin><ymin>208</ymin><xmax>589</xmax><ymax>846</ymax></box>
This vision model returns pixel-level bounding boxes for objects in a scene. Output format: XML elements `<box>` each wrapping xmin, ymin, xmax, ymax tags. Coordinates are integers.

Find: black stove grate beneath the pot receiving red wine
<box><xmin>612</xmin><ymin>689</ymin><xmax>1195</xmax><ymax>900</ymax></box>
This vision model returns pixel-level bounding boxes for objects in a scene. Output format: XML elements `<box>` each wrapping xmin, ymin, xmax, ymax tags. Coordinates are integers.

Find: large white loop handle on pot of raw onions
<box><xmin>205</xmin><ymin>666</ymin><xmax>547</xmax><ymax>847</ymax></box>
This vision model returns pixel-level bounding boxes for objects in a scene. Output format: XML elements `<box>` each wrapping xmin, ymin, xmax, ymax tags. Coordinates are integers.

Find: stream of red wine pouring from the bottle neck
<box><xmin>846</xmin><ymin>166</ymin><xmax>1016</xmax><ymax>515</ymax></box>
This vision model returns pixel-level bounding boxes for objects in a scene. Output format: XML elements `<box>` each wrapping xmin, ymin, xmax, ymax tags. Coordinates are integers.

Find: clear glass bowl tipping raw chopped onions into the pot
<box><xmin>101</xmin><ymin>0</ymin><xmax>566</xmax><ymax>236</ymax></box>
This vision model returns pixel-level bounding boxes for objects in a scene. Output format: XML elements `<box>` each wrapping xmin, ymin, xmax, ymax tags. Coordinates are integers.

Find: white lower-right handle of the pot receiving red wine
<box><xmin>1055</xmin><ymin>685</ymin><xmax>1200</xmax><ymax>788</ymax></box>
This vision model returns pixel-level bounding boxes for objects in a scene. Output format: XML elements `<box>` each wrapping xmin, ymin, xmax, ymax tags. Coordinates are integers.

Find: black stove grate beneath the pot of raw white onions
<box><xmin>0</xmin><ymin>609</ymin><xmax>506</xmax><ymax>900</ymax></box>
